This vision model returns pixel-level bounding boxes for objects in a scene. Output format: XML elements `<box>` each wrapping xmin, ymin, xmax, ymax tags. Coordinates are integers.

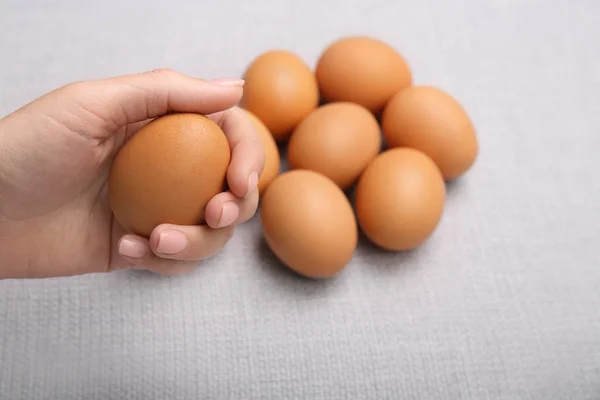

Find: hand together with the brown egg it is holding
<box><xmin>0</xmin><ymin>70</ymin><xmax>265</xmax><ymax>279</ymax></box>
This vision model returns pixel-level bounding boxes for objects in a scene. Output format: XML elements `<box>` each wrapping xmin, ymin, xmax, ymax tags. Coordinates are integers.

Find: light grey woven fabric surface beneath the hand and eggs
<box><xmin>0</xmin><ymin>0</ymin><xmax>600</xmax><ymax>399</ymax></box>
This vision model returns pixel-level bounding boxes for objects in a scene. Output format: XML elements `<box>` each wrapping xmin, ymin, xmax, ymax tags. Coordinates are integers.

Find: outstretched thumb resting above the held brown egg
<box><xmin>57</xmin><ymin>69</ymin><xmax>244</xmax><ymax>139</ymax></box>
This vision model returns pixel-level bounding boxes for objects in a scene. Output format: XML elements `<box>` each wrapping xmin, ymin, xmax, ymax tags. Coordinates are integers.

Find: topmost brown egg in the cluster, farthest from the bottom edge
<box><xmin>316</xmin><ymin>37</ymin><xmax>412</xmax><ymax>114</ymax></box>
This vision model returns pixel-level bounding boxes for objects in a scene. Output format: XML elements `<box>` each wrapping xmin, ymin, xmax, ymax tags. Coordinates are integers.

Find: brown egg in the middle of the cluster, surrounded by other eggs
<box><xmin>288</xmin><ymin>102</ymin><xmax>381</xmax><ymax>190</ymax></box>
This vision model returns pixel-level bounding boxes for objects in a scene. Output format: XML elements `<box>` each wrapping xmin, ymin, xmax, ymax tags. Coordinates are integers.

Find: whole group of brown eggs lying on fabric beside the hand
<box><xmin>240</xmin><ymin>37</ymin><xmax>478</xmax><ymax>278</ymax></box>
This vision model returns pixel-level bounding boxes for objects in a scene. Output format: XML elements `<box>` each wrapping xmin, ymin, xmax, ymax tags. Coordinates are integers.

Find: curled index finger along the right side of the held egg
<box><xmin>209</xmin><ymin>107</ymin><xmax>265</xmax><ymax>197</ymax></box>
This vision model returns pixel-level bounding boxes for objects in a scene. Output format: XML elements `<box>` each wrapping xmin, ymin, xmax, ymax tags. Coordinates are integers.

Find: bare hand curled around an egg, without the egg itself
<box><xmin>0</xmin><ymin>70</ymin><xmax>265</xmax><ymax>279</ymax></box>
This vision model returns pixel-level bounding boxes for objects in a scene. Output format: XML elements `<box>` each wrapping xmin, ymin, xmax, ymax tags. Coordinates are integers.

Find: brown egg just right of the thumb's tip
<box><xmin>240</xmin><ymin>50</ymin><xmax>319</xmax><ymax>141</ymax></box>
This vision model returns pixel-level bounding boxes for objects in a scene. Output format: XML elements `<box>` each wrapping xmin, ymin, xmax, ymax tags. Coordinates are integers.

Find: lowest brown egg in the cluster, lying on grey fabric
<box><xmin>261</xmin><ymin>170</ymin><xmax>358</xmax><ymax>279</ymax></box>
